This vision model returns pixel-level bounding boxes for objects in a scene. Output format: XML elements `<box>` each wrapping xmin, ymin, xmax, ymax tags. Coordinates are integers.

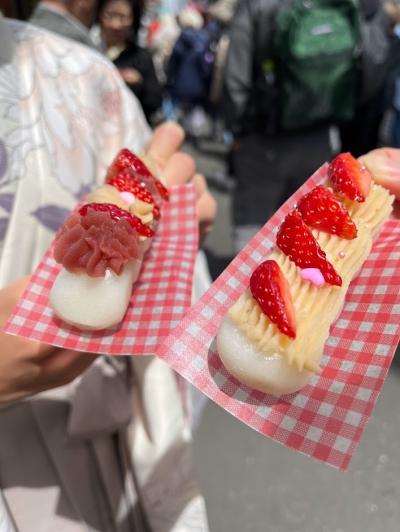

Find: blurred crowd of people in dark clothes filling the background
<box><xmin>23</xmin><ymin>0</ymin><xmax>400</xmax><ymax>250</ymax></box>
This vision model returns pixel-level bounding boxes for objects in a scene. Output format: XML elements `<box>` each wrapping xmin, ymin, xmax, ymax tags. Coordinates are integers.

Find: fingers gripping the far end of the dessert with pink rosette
<box><xmin>147</xmin><ymin>122</ymin><xmax>217</xmax><ymax>243</ymax></box>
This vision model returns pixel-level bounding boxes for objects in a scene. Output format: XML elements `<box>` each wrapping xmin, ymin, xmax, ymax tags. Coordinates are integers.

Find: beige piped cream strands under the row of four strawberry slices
<box><xmin>228</xmin><ymin>184</ymin><xmax>394</xmax><ymax>372</ymax></box>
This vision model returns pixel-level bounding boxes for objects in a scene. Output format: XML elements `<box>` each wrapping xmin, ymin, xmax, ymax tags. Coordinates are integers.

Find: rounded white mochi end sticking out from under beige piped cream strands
<box><xmin>217</xmin><ymin>316</ymin><xmax>313</xmax><ymax>397</ymax></box>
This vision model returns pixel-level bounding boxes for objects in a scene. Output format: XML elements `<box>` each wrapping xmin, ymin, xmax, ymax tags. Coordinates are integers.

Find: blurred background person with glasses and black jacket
<box><xmin>98</xmin><ymin>0</ymin><xmax>162</xmax><ymax>122</ymax></box>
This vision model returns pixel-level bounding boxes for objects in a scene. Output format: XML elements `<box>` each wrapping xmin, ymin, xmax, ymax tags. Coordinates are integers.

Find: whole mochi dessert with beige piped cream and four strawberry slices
<box><xmin>217</xmin><ymin>153</ymin><xmax>393</xmax><ymax>396</ymax></box>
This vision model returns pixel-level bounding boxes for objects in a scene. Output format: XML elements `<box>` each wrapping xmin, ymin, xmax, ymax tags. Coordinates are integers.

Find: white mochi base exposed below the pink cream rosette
<box><xmin>50</xmin><ymin>260</ymin><xmax>141</xmax><ymax>330</ymax></box>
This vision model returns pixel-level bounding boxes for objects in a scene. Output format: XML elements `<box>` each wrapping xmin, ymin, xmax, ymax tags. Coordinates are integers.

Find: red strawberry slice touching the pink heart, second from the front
<box><xmin>276</xmin><ymin>209</ymin><xmax>342</xmax><ymax>286</ymax></box>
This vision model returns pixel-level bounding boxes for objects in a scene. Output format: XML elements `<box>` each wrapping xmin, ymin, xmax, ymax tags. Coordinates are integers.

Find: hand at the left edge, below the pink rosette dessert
<box><xmin>0</xmin><ymin>277</ymin><xmax>96</xmax><ymax>404</ymax></box>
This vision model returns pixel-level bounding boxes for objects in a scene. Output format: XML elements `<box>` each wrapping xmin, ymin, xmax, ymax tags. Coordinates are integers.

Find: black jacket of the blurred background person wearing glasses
<box><xmin>114</xmin><ymin>42</ymin><xmax>162</xmax><ymax>119</ymax></box>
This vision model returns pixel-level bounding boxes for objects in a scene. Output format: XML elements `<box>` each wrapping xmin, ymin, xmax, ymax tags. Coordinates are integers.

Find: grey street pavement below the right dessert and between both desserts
<box><xmin>186</xmin><ymin>140</ymin><xmax>400</xmax><ymax>532</ymax></box>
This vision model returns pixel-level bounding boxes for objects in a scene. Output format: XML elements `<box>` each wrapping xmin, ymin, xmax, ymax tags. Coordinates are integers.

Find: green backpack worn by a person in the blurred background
<box><xmin>274</xmin><ymin>0</ymin><xmax>360</xmax><ymax>130</ymax></box>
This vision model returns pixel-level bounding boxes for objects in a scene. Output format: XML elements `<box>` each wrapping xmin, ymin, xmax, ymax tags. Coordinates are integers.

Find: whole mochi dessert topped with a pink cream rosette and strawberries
<box><xmin>50</xmin><ymin>149</ymin><xmax>169</xmax><ymax>330</ymax></box>
